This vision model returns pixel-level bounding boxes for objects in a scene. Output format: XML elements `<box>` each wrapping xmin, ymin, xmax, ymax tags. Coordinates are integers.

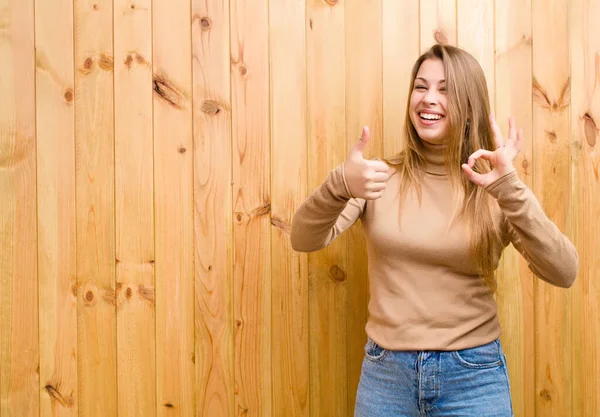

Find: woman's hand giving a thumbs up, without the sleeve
<box><xmin>344</xmin><ymin>126</ymin><xmax>389</xmax><ymax>200</ymax></box>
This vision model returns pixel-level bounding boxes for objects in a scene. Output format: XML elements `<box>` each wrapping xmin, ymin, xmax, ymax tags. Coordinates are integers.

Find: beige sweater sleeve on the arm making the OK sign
<box><xmin>486</xmin><ymin>171</ymin><xmax>579</xmax><ymax>288</ymax></box>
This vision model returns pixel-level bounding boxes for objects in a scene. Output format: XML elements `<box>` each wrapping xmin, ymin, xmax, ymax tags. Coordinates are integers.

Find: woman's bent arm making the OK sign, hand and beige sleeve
<box><xmin>462</xmin><ymin>116</ymin><xmax>579</xmax><ymax>288</ymax></box>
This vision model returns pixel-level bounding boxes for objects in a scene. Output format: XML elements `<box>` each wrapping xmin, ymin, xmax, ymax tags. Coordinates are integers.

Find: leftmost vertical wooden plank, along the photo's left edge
<box><xmin>0</xmin><ymin>0</ymin><xmax>39</xmax><ymax>417</ymax></box>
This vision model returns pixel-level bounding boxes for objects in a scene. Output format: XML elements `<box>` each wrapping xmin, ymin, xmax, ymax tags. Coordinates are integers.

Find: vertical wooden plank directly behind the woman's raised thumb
<box><xmin>345</xmin><ymin>0</ymin><xmax>383</xmax><ymax>411</ymax></box>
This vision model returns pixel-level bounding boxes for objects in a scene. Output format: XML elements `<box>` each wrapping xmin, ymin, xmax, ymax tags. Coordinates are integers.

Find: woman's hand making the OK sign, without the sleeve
<box><xmin>462</xmin><ymin>115</ymin><xmax>523</xmax><ymax>188</ymax></box>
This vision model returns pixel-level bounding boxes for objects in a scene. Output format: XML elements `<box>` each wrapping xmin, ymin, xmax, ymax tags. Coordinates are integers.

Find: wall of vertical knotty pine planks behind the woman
<box><xmin>0</xmin><ymin>0</ymin><xmax>600</xmax><ymax>417</ymax></box>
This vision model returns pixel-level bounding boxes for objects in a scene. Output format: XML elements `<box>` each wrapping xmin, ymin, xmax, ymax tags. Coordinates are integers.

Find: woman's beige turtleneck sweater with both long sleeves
<box><xmin>291</xmin><ymin>143</ymin><xmax>579</xmax><ymax>350</ymax></box>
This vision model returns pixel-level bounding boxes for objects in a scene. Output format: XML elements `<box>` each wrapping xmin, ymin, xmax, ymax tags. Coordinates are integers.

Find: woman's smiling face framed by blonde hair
<box><xmin>409</xmin><ymin>58</ymin><xmax>449</xmax><ymax>145</ymax></box>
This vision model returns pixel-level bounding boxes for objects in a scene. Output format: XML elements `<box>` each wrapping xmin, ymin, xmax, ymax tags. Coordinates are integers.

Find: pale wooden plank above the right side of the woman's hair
<box><xmin>456</xmin><ymin>0</ymin><xmax>494</xmax><ymax>111</ymax></box>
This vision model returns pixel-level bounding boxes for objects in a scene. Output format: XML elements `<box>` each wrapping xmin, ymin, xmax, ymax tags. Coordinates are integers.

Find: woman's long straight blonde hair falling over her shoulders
<box><xmin>387</xmin><ymin>44</ymin><xmax>501</xmax><ymax>292</ymax></box>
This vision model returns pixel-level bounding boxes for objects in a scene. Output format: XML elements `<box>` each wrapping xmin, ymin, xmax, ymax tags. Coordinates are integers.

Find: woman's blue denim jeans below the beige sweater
<box><xmin>354</xmin><ymin>339</ymin><xmax>513</xmax><ymax>417</ymax></box>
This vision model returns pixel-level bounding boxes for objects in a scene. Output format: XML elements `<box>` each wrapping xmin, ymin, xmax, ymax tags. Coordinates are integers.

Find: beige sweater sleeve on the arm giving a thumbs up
<box><xmin>290</xmin><ymin>165</ymin><xmax>366</xmax><ymax>252</ymax></box>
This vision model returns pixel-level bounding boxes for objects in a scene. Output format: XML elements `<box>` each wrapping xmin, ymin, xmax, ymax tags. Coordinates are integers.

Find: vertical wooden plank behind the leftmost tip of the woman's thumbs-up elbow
<box><xmin>269</xmin><ymin>0</ymin><xmax>310</xmax><ymax>417</ymax></box>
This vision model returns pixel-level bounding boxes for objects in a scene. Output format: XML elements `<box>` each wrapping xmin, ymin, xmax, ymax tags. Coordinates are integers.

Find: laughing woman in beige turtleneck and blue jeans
<box><xmin>291</xmin><ymin>45</ymin><xmax>579</xmax><ymax>417</ymax></box>
